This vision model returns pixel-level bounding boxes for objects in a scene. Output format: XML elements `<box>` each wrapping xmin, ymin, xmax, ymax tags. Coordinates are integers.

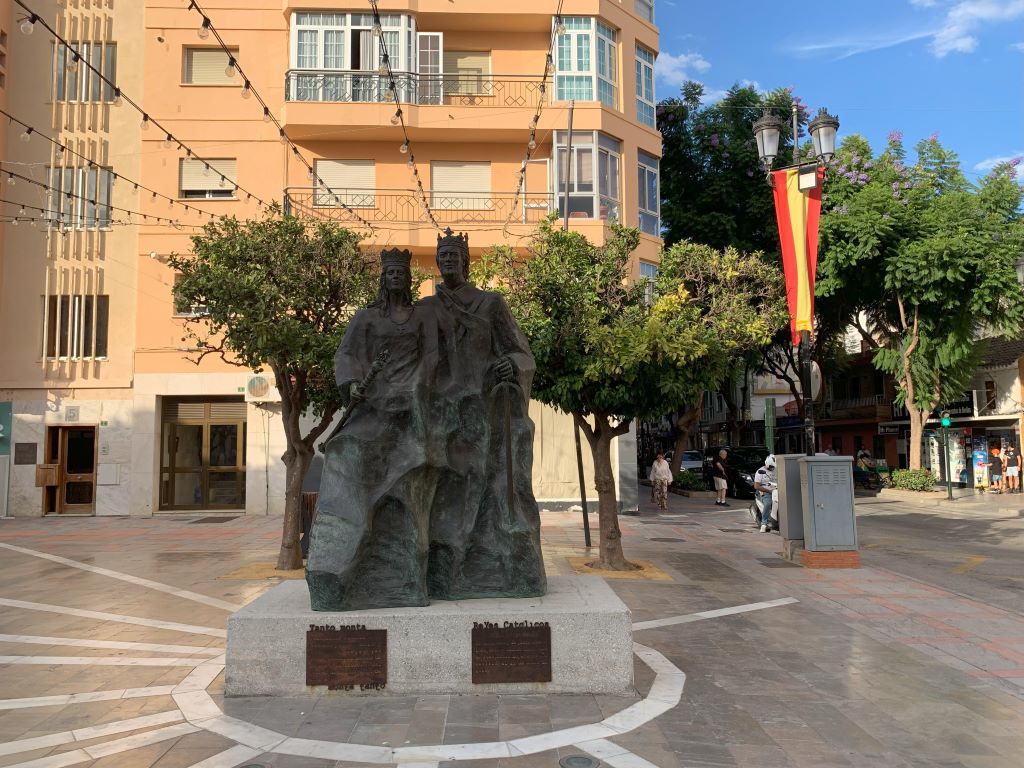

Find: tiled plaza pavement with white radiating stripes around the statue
<box><xmin>0</xmin><ymin>497</ymin><xmax>1024</xmax><ymax>768</ymax></box>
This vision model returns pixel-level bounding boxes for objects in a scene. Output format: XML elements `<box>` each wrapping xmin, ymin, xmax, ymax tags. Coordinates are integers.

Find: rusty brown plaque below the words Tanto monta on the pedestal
<box><xmin>306</xmin><ymin>625</ymin><xmax>387</xmax><ymax>690</ymax></box>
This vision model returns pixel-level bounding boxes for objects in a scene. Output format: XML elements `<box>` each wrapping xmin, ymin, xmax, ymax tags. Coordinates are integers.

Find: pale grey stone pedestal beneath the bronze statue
<box><xmin>224</xmin><ymin>577</ymin><xmax>634</xmax><ymax>696</ymax></box>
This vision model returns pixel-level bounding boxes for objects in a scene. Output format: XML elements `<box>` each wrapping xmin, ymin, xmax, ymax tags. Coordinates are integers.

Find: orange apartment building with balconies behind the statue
<box><xmin>0</xmin><ymin>0</ymin><xmax>662</xmax><ymax>516</ymax></box>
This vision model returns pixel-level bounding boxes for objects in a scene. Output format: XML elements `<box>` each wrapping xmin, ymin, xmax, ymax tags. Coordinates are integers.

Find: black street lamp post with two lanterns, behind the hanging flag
<box><xmin>754</xmin><ymin>101</ymin><xmax>839</xmax><ymax>456</ymax></box>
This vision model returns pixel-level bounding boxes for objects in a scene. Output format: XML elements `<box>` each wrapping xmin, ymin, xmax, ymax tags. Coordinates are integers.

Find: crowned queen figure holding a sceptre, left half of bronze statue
<box><xmin>306</xmin><ymin>250</ymin><xmax>440</xmax><ymax>610</ymax></box>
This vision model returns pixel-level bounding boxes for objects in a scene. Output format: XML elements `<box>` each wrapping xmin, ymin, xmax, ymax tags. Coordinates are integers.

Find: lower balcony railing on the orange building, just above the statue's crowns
<box><xmin>285</xmin><ymin>187</ymin><xmax>555</xmax><ymax>224</ymax></box>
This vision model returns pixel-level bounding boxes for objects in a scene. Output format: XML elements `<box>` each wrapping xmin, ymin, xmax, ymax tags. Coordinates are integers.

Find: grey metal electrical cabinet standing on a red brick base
<box><xmin>799</xmin><ymin>456</ymin><xmax>857</xmax><ymax>552</ymax></box>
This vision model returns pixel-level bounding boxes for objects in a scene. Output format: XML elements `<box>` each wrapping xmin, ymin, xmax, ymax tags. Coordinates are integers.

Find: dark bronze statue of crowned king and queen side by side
<box><xmin>306</xmin><ymin>229</ymin><xmax>546</xmax><ymax>610</ymax></box>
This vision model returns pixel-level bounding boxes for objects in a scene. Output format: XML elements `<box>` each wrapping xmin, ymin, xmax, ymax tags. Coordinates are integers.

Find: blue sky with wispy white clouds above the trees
<box><xmin>655</xmin><ymin>0</ymin><xmax>1024</xmax><ymax>176</ymax></box>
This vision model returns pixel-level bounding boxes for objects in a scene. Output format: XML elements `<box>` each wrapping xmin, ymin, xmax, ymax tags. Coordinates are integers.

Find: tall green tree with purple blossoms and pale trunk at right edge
<box><xmin>818</xmin><ymin>132</ymin><xmax>1024</xmax><ymax>469</ymax></box>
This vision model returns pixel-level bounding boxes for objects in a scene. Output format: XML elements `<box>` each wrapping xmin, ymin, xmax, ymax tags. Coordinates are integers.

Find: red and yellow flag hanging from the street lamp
<box><xmin>771</xmin><ymin>167</ymin><xmax>824</xmax><ymax>346</ymax></box>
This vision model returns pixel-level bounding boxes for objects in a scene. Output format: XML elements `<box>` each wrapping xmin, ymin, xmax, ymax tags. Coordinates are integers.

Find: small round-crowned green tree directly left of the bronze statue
<box><xmin>169</xmin><ymin>208</ymin><xmax>378</xmax><ymax>569</ymax></box>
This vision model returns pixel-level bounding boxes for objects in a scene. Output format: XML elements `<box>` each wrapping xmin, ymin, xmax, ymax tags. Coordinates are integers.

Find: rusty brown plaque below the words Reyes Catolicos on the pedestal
<box><xmin>473</xmin><ymin>622</ymin><xmax>551</xmax><ymax>683</ymax></box>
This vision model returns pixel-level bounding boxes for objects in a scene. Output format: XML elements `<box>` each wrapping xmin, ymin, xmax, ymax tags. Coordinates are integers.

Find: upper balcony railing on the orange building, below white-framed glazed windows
<box><xmin>285</xmin><ymin>70</ymin><xmax>548</xmax><ymax>108</ymax></box>
